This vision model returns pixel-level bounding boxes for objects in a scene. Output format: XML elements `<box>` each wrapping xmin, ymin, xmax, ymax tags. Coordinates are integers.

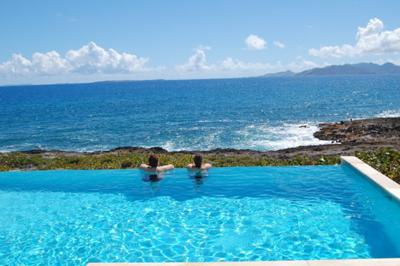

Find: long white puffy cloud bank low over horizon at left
<box><xmin>0</xmin><ymin>42</ymin><xmax>148</xmax><ymax>75</ymax></box>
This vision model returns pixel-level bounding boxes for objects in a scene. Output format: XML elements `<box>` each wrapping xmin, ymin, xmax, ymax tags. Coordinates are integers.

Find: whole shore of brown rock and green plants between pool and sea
<box><xmin>0</xmin><ymin>118</ymin><xmax>400</xmax><ymax>183</ymax></box>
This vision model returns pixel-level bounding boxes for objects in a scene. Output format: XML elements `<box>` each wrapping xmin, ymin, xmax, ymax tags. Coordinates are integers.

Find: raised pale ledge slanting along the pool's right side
<box><xmin>340</xmin><ymin>156</ymin><xmax>400</xmax><ymax>201</ymax></box>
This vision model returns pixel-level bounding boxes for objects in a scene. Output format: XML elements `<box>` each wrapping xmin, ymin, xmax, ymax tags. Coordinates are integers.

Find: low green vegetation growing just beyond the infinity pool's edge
<box><xmin>0</xmin><ymin>149</ymin><xmax>400</xmax><ymax>183</ymax></box>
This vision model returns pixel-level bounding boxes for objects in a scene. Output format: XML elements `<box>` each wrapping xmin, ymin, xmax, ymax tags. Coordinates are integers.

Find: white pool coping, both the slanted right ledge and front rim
<box><xmin>88</xmin><ymin>156</ymin><xmax>400</xmax><ymax>266</ymax></box>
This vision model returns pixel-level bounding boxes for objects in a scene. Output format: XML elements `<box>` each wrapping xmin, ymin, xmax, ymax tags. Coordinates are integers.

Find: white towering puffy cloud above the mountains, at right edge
<box><xmin>309</xmin><ymin>18</ymin><xmax>400</xmax><ymax>58</ymax></box>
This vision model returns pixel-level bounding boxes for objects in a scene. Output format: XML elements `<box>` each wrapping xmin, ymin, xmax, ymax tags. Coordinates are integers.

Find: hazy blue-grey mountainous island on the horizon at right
<box><xmin>261</xmin><ymin>63</ymin><xmax>400</xmax><ymax>77</ymax></box>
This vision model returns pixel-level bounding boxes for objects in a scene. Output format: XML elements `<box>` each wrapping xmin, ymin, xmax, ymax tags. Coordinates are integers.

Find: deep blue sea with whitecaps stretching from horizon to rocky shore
<box><xmin>0</xmin><ymin>76</ymin><xmax>400</xmax><ymax>151</ymax></box>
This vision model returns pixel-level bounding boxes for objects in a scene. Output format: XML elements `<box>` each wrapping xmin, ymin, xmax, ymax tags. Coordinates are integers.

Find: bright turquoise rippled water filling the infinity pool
<box><xmin>0</xmin><ymin>166</ymin><xmax>400</xmax><ymax>265</ymax></box>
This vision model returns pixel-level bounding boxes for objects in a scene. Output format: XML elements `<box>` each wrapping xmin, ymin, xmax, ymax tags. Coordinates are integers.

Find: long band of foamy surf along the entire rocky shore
<box><xmin>0</xmin><ymin>122</ymin><xmax>330</xmax><ymax>152</ymax></box>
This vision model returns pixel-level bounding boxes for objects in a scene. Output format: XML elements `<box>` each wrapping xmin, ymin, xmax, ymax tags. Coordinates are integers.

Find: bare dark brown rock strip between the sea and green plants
<box><xmin>10</xmin><ymin>117</ymin><xmax>400</xmax><ymax>159</ymax></box>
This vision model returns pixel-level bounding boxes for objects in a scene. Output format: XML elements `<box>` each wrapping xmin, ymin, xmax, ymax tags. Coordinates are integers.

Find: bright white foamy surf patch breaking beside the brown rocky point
<box><xmin>235</xmin><ymin>122</ymin><xmax>330</xmax><ymax>150</ymax></box>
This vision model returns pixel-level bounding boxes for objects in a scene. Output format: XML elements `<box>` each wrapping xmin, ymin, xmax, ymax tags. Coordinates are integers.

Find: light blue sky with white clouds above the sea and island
<box><xmin>0</xmin><ymin>0</ymin><xmax>400</xmax><ymax>85</ymax></box>
